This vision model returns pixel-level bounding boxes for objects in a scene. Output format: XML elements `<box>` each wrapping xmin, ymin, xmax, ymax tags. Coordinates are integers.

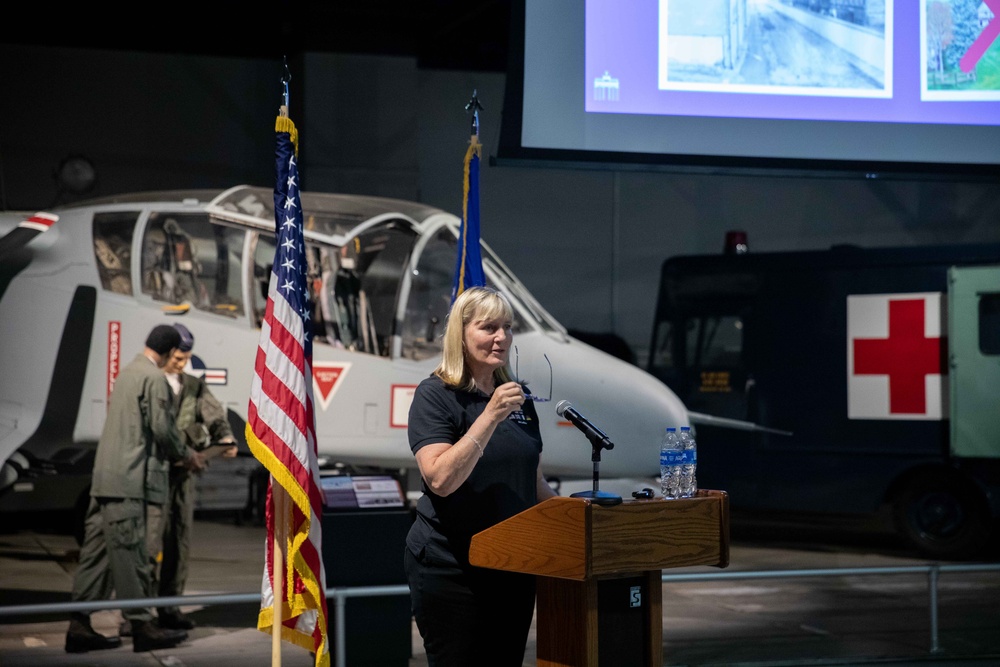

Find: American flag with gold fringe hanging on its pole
<box><xmin>246</xmin><ymin>115</ymin><xmax>330</xmax><ymax>667</ymax></box>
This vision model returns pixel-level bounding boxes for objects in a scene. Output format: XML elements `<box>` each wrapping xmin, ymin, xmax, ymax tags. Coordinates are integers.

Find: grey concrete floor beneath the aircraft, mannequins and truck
<box><xmin>0</xmin><ymin>508</ymin><xmax>1000</xmax><ymax>667</ymax></box>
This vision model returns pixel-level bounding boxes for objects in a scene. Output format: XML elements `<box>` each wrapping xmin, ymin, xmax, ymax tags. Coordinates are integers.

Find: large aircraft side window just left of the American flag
<box><xmin>142</xmin><ymin>212</ymin><xmax>245</xmax><ymax>318</ymax></box>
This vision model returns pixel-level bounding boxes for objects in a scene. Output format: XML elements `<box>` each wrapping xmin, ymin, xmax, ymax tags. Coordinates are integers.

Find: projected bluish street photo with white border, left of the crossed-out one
<box><xmin>659</xmin><ymin>0</ymin><xmax>893</xmax><ymax>97</ymax></box>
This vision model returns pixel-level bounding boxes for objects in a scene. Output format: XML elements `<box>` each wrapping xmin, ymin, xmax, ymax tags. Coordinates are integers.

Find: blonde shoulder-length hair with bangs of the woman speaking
<box><xmin>434</xmin><ymin>287</ymin><xmax>514</xmax><ymax>391</ymax></box>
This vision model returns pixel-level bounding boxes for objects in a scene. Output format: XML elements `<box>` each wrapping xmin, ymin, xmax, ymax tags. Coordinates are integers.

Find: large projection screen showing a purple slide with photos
<box><xmin>532</xmin><ymin>0</ymin><xmax>1000</xmax><ymax>170</ymax></box>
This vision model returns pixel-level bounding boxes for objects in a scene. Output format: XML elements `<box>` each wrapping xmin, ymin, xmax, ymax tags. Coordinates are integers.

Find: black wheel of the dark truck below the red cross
<box><xmin>893</xmin><ymin>475</ymin><xmax>990</xmax><ymax>560</ymax></box>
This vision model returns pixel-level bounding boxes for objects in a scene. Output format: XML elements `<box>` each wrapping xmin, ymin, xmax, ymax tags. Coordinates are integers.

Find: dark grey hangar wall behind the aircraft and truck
<box><xmin>0</xmin><ymin>11</ymin><xmax>1000</xmax><ymax>363</ymax></box>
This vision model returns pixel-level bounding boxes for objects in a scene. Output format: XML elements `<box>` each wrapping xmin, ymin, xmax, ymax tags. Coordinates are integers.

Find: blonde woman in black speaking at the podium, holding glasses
<box><xmin>404</xmin><ymin>287</ymin><xmax>556</xmax><ymax>667</ymax></box>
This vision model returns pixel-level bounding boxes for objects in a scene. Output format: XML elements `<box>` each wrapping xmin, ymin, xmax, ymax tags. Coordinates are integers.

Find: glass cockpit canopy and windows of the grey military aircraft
<box><xmin>92</xmin><ymin>186</ymin><xmax>565</xmax><ymax>368</ymax></box>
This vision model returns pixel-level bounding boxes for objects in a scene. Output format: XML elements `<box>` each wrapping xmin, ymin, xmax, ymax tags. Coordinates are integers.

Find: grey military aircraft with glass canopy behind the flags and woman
<box><xmin>0</xmin><ymin>186</ymin><xmax>690</xmax><ymax>524</ymax></box>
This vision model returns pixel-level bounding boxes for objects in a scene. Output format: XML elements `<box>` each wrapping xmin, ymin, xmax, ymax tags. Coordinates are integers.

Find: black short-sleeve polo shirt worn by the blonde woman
<box><xmin>407</xmin><ymin>375</ymin><xmax>542</xmax><ymax>562</ymax></box>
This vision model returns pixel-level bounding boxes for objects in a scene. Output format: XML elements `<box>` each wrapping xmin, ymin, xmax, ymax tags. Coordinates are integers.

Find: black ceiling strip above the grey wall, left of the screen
<box><xmin>11</xmin><ymin>0</ymin><xmax>512</xmax><ymax>72</ymax></box>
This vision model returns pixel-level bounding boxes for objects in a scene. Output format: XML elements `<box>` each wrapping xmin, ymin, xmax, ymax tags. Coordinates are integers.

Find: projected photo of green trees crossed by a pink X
<box><xmin>920</xmin><ymin>0</ymin><xmax>1000</xmax><ymax>100</ymax></box>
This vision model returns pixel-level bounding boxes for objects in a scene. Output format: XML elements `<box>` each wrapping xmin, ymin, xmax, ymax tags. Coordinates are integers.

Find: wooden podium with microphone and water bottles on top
<box><xmin>469</xmin><ymin>490</ymin><xmax>729</xmax><ymax>667</ymax></box>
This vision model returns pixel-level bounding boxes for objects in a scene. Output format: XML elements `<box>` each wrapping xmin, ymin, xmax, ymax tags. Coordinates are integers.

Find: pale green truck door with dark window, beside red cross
<box><xmin>948</xmin><ymin>266</ymin><xmax>1000</xmax><ymax>458</ymax></box>
